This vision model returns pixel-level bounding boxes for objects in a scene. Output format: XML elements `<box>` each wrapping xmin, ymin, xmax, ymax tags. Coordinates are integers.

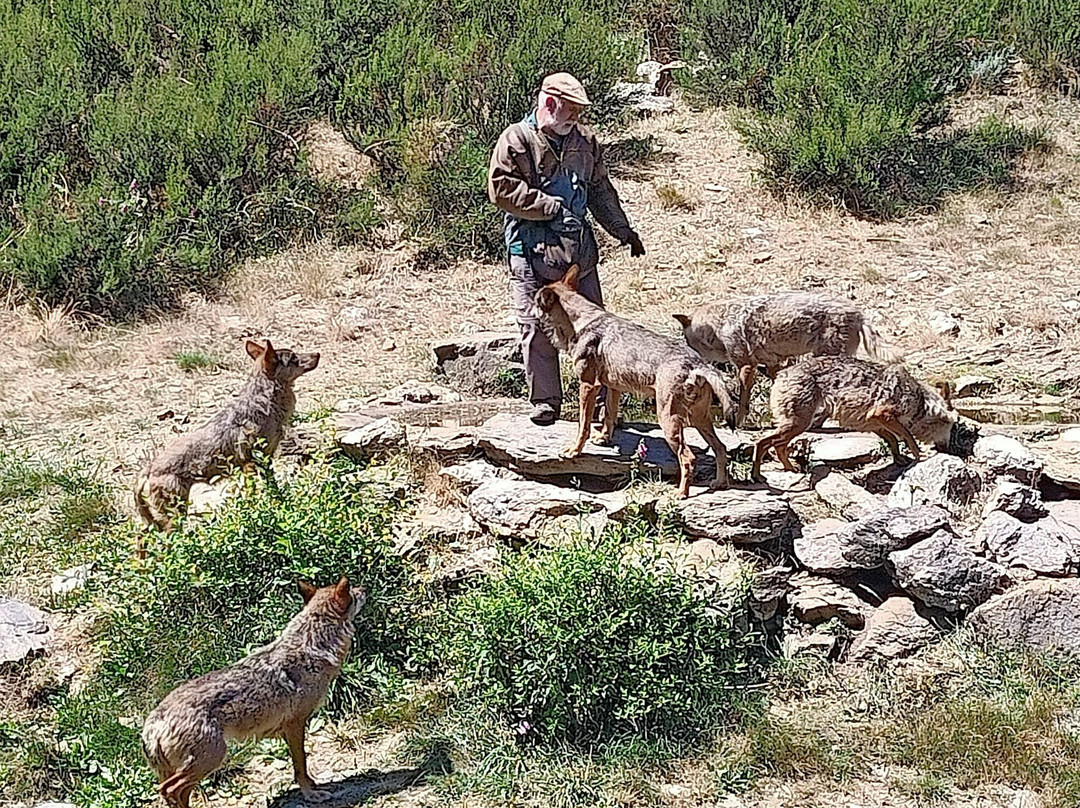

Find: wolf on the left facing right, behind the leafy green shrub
<box><xmin>135</xmin><ymin>339</ymin><xmax>319</xmax><ymax>529</ymax></box>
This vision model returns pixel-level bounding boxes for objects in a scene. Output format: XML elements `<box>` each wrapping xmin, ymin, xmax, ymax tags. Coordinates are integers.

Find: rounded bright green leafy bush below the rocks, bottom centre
<box><xmin>448</xmin><ymin>531</ymin><xmax>755</xmax><ymax>744</ymax></box>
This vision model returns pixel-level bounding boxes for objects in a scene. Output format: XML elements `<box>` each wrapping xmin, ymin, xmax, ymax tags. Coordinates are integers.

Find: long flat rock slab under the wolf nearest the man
<box><xmin>477</xmin><ymin>414</ymin><xmax>744</xmax><ymax>479</ymax></box>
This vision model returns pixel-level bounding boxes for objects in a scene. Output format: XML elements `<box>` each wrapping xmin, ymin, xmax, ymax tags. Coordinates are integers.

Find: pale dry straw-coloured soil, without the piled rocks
<box><xmin>0</xmin><ymin>88</ymin><xmax>1080</xmax><ymax>808</ymax></box>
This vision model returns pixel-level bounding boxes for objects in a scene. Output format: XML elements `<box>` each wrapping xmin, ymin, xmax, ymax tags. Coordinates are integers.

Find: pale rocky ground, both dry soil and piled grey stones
<box><xmin>0</xmin><ymin>82</ymin><xmax>1080</xmax><ymax>808</ymax></box>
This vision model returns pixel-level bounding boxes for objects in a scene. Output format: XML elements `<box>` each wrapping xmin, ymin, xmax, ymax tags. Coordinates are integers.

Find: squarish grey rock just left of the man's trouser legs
<box><xmin>432</xmin><ymin>332</ymin><xmax>525</xmax><ymax>394</ymax></box>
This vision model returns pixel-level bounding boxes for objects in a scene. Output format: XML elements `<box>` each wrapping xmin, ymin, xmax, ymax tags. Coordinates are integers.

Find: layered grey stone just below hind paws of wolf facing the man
<box><xmin>677</xmin><ymin>489</ymin><xmax>797</xmax><ymax>544</ymax></box>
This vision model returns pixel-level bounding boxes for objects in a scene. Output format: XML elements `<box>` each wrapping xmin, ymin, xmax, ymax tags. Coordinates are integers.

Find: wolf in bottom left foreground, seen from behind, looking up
<box><xmin>143</xmin><ymin>577</ymin><xmax>367</xmax><ymax>808</ymax></box>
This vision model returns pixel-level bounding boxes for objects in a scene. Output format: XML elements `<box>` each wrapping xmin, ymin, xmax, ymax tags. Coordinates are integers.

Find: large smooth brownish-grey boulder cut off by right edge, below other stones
<box><xmin>968</xmin><ymin>578</ymin><xmax>1080</xmax><ymax>657</ymax></box>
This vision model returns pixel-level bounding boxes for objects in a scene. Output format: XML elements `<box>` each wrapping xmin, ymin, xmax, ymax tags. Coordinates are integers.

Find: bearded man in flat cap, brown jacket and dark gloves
<box><xmin>487</xmin><ymin>72</ymin><xmax>645</xmax><ymax>426</ymax></box>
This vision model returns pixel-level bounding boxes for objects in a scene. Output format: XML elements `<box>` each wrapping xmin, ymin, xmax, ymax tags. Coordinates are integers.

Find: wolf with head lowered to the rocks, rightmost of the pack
<box><xmin>753</xmin><ymin>356</ymin><xmax>958</xmax><ymax>479</ymax></box>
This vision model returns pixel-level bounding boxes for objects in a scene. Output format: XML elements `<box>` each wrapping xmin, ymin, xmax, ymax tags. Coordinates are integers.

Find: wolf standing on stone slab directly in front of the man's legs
<box><xmin>536</xmin><ymin>266</ymin><xmax>731</xmax><ymax>497</ymax></box>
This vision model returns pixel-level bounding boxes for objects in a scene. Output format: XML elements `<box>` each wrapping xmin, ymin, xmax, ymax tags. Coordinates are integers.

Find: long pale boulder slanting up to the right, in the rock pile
<box><xmin>795</xmin><ymin>506</ymin><xmax>948</xmax><ymax>575</ymax></box>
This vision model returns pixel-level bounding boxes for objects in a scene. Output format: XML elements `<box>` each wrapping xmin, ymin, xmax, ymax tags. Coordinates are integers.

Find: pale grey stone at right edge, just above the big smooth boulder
<box><xmin>976</xmin><ymin>511</ymin><xmax>1080</xmax><ymax>576</ymax></box>
